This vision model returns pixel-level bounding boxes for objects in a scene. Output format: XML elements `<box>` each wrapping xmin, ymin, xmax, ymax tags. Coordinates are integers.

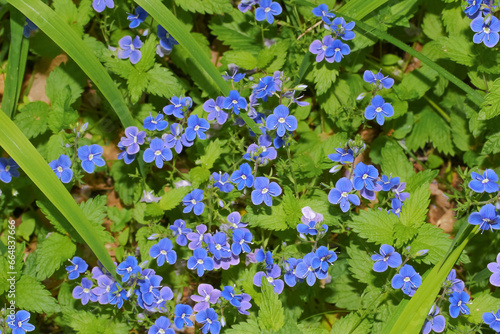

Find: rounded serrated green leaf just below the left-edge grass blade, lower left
<box><xmin>36</xmin><ymin>233</ymin><xmax>76</xmax><ymax>281</ymax></box>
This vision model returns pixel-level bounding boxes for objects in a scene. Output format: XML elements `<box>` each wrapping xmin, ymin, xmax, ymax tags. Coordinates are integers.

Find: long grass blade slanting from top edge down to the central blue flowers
<box><xmin>134</xmin><ymin>0</ymin><xmax>262</xmax><ymax>134</ymax></box>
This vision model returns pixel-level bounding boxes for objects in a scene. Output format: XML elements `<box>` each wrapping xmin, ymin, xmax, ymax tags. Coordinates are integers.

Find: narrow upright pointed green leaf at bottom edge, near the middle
<box><xmin>259</xmin><ymin>277</ymin><xmax>285</xmax><ymax>331</ymax></box>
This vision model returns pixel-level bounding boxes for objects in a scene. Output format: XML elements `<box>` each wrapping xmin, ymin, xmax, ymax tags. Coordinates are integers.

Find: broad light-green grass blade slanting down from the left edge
<box><xmin>0</xmin><ymin>112</ymin><xmax>115</xmax><ymax>274</ymax></box>
